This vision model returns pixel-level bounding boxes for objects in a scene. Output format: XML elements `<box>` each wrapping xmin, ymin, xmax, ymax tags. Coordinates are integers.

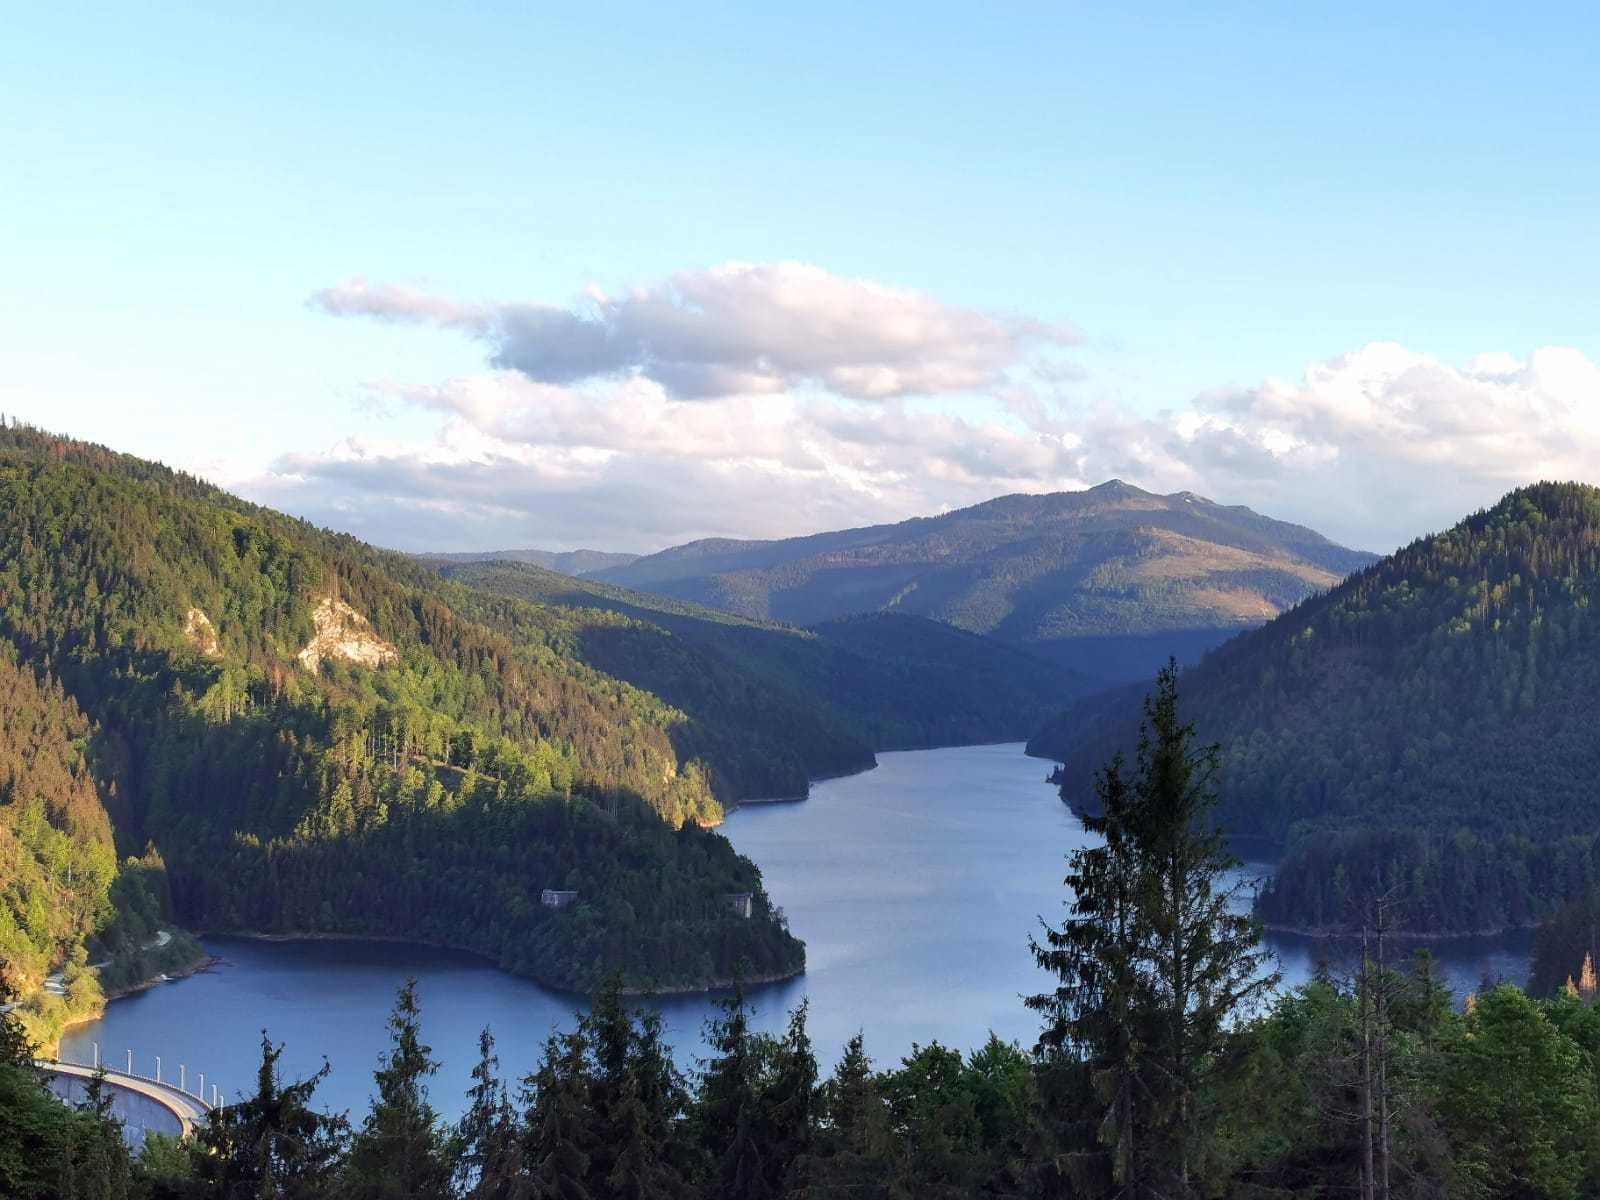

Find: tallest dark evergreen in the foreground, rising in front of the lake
<box><xmin>1029</xmin><ymin>662</ymin><xmax>1277</xmax><ymax>1197</ymax></box>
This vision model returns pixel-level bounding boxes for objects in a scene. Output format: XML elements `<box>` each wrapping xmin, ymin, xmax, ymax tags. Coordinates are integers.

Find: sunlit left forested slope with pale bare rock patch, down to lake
<box><xmin>0</xmin><ymin>427</ymin><xmax>802</xmax><ymax>986</ymax></box>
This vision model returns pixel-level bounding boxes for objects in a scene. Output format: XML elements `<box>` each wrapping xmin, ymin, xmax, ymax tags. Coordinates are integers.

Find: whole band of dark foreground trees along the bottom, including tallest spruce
<box><xmin>12</xmin><ymin>672</ymin><xmax>1600</xmax><ymax>1200</ymax></box>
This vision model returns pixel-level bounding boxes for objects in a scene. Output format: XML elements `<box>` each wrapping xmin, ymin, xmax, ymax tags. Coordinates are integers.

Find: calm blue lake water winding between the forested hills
<box><xmin>62</xmin><ymin>744</ymin><xmax>1528</xmax><ymax>1114</ymax></box>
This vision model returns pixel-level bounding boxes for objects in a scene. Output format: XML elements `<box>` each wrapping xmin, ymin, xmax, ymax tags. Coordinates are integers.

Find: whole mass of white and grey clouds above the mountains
<box><xmin>256</xmin><ymin>264</ymin><xmax>1600</xmax><ymax>550</ymax></box>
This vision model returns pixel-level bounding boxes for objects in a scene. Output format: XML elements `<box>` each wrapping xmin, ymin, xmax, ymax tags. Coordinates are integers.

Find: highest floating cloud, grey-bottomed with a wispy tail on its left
<box><xmin>312</xmin><ymin>262</ymin><xmax>1077</xmax><ymax>400</ymax></box>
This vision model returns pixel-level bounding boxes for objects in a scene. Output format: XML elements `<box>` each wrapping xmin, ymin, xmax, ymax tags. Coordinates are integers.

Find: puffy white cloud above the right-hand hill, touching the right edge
<box><xmin>1056</xmin><ymin>342</ymin><xmax>1600</xmax><ymax>550</ymax></box>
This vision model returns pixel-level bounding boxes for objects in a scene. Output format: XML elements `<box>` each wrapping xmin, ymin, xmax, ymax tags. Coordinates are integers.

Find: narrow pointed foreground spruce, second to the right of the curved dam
<box><xmin>341</xmin><ymin>979</ymin><xmax>450</xmax><ymax>1200</ymax></box>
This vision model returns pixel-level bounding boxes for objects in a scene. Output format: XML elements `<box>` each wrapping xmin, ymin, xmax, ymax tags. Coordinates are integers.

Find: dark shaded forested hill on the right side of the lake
<box><xmin>1029</xmin><ymin>483</ymin><xmax>1600</xmax><ymax>931</ymax></box>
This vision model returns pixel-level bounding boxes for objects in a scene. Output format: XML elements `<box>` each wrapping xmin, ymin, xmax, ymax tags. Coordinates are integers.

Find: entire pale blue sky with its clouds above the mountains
<box><xmin>0</xmin><ymin>3</ymin><xmax>1600</xmax><ymax>550</ymax></box>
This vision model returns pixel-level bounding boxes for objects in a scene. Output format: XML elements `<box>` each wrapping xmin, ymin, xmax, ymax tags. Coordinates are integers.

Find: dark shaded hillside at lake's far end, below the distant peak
<box><xmin>443</xmin><ymin>563</ymin><xmax>1091</xmax><ymax>774</ymax></box>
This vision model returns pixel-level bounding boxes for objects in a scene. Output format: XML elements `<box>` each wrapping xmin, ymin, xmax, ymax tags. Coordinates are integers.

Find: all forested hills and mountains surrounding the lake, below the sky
<box><xmin>0</xmin><ymin>426</ymin><xmax>1600</xmax><ymax>1049</ymax></box>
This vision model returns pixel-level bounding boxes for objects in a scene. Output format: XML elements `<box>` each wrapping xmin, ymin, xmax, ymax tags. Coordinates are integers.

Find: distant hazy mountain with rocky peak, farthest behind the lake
<box><xmin>594</xmin><ymin>480</ymin><xmax>1373</xmax><ymax>680</ymax></box>
